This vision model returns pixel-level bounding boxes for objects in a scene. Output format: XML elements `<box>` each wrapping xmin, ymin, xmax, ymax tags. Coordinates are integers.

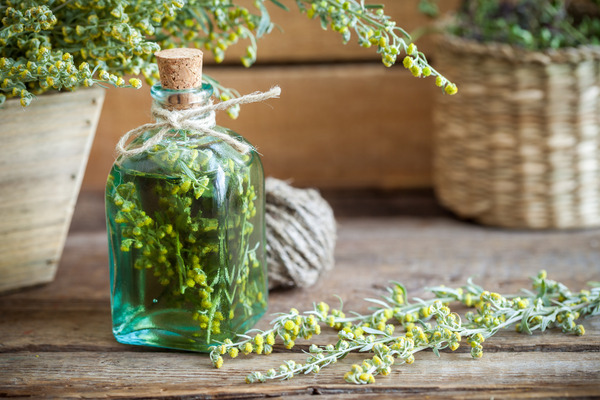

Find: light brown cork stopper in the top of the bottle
<box><xmin>154</xmin><ymin>48</ymin><xmax>202</xmax><ymax>90</ymax></box>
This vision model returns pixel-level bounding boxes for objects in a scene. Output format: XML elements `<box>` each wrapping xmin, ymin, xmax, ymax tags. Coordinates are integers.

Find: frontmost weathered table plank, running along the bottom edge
<box><xmin>0</xmin><ymin>352</ymin><xmax>600</xmax><ymax>398</ymax></box>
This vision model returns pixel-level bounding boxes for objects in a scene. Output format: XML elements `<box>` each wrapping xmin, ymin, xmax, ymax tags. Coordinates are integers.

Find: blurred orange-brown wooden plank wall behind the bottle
<box><xmin>82</xmin><ymin>0</ymin><xmax>458</xmax><ymax>191</ymax></box>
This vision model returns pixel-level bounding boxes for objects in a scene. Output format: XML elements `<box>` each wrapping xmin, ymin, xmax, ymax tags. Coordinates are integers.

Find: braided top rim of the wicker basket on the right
<box><xmin>437</xmin><ymin>33</ymin><xmax>600</xmax><ymax>64</ymax></box>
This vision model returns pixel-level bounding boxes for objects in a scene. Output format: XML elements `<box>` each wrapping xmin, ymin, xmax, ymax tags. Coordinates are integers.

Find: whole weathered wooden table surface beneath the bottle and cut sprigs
<box><xmin>0</xmin><ymin>192</ymin><xmax>600</xmax><ymax>399</ymax></box>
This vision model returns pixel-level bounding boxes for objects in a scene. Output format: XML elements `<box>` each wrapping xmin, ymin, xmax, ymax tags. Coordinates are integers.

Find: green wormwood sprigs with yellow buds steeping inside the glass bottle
<box><xmin>106</xmin><ymin>138</ymin><xmax>266</xmax><ymax>347</ymax></box>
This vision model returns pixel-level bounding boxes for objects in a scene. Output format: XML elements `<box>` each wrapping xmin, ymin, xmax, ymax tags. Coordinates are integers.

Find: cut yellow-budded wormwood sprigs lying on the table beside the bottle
<box><xmin>211</xmin><ymin>271</ymin><xmax>600</xmax><ymax>384</ymax></box>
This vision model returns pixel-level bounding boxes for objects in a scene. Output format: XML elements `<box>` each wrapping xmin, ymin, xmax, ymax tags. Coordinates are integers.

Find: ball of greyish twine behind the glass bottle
<box><xmin>265</xmin><ymin>178</ymin><xmax>337</xmax><ymax>289</ymax></box>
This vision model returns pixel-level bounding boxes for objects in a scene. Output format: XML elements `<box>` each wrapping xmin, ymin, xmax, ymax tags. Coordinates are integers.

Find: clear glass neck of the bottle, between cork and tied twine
<box><xmin>150</xmin><ymin>83</ymin><xmax>213</xmax><ymax>111</ymax></box>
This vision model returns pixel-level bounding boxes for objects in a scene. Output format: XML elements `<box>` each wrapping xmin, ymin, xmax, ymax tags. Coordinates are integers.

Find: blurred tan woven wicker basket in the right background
<box><xmin>434</xmin><ymin>36</ymin><xmax>600</xmax><ymax>229</ymax></box>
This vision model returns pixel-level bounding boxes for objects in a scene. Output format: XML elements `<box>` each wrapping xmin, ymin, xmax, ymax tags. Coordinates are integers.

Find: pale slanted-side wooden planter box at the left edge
<box><xmin>0</xmin><ymin>89</ymin><xmax>104</xmax><ymax>292</ymax></box>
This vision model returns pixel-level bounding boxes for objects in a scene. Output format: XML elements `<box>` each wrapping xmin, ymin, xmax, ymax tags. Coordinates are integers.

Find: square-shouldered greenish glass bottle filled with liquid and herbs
<box><xmin>106</xmin><ymin>48</ymin><xmax>268</xmax><ymax>351</ymax></box>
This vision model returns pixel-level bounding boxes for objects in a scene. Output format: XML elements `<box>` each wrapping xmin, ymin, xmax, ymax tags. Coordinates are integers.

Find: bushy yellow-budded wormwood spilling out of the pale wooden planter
<box><xmin>0</xmin><ymin>0</ymin><xmax>456</xmax><ymax>108</ymax></box>
